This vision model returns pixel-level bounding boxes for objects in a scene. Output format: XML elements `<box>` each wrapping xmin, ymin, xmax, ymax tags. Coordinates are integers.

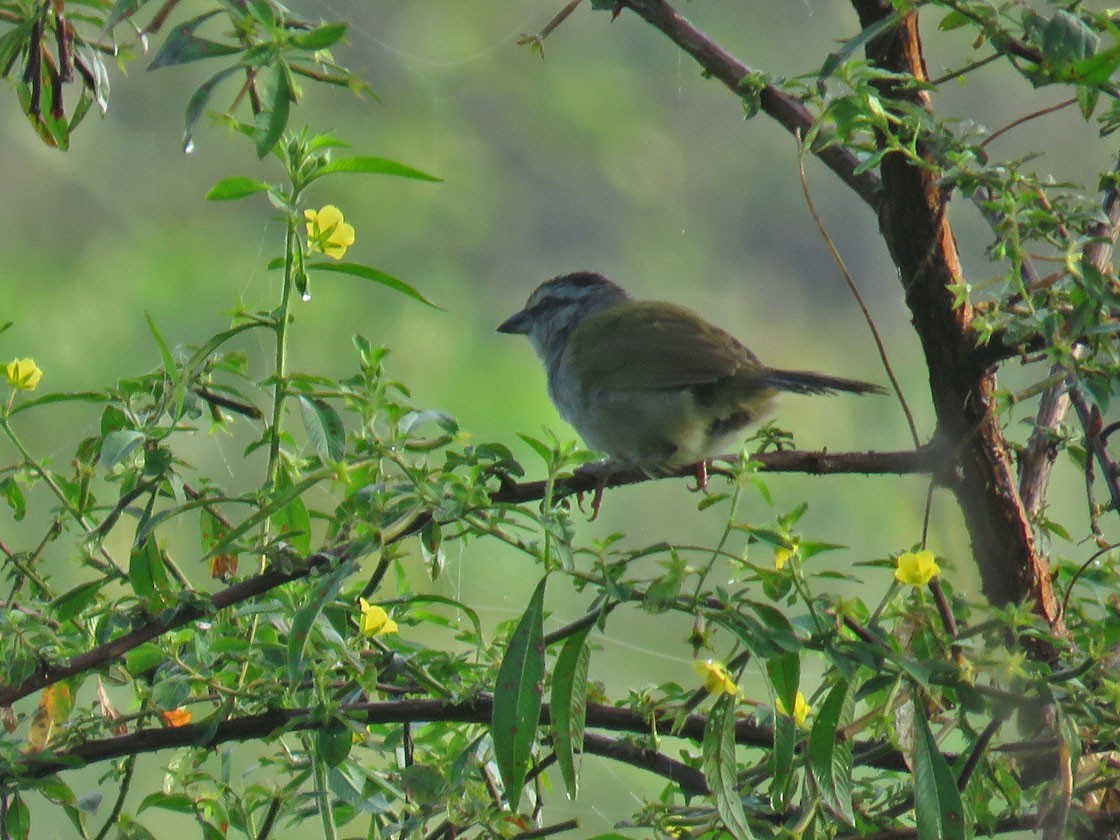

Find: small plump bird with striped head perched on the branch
<box><xmin>497</xmin><ymin>271</ymin><xmax>886</xmax><ymax>487</ymax></box>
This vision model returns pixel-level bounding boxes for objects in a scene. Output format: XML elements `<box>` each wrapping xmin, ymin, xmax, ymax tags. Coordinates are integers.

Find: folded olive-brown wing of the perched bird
<box><xmin>568</xmin><ymin>300</ymin><xmax>759</xmax><ymax>391</ymax></box>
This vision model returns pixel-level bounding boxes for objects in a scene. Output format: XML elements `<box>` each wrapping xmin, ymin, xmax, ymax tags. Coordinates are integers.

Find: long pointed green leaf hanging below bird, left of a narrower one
<box><xmin>491</xmin><ymin>575</ymin><xmax>549</xmax><ymax>811</ymax></box>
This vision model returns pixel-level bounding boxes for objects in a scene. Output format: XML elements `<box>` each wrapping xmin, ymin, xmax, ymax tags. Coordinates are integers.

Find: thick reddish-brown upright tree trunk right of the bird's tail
<box><xmin>852</xmin><ymin>0</ymin><xmax>1061</xmax><ymax>627</ymax></box>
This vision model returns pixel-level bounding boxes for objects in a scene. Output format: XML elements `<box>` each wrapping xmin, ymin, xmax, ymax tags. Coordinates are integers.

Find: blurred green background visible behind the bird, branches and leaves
<box><xmin>0</xmin><ymin>0</ymin><xmax>1112</xmax><ymax>831</ymax></box>
